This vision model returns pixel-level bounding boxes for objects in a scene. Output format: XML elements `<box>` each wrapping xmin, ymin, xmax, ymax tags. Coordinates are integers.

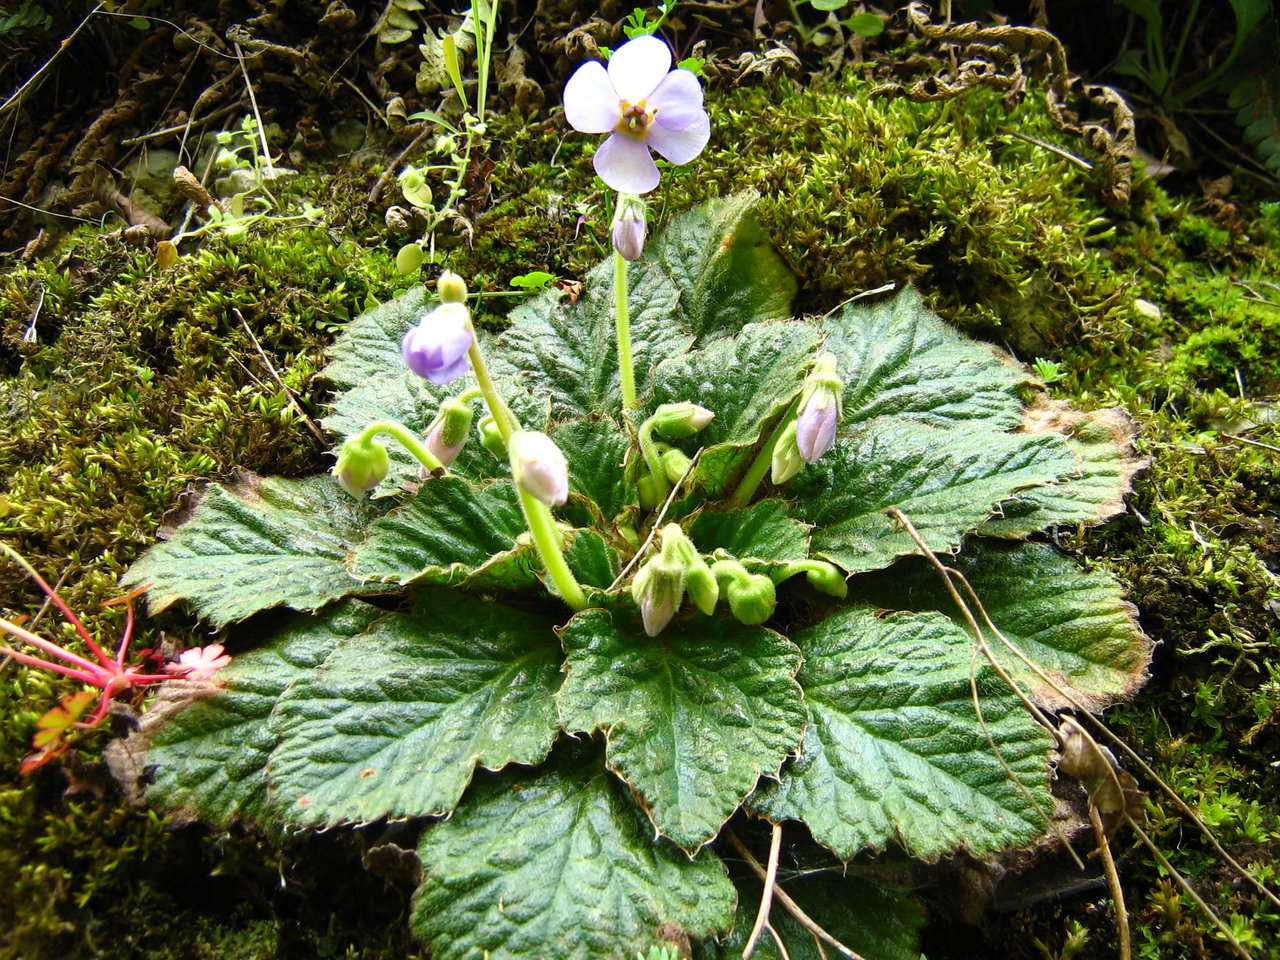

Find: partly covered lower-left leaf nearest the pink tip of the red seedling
<box><xmin>139</xmin><ymin>600</ymin><xmax>385</xmax><ymax>827</ymax></box>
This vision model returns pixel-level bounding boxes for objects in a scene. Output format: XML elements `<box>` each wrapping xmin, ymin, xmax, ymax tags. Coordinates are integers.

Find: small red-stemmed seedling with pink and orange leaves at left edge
<box><xmin>0</xmin><ymin>544</ymin><xmax>232</xmax><ymax>773</ymax></box>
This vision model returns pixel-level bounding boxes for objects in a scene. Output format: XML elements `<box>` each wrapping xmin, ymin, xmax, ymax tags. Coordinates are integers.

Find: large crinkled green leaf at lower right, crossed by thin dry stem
<box><xmin>749</xmin><ymin>607</ymin><xmax>1051</xmax><ymax>860</ymax></box>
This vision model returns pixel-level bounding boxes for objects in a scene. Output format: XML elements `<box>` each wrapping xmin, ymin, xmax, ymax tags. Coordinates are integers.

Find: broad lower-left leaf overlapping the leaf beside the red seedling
<box><xmin>269</xmin><ymin>588</ymin><xmax>563</xmax><ymax>824</ymax></box>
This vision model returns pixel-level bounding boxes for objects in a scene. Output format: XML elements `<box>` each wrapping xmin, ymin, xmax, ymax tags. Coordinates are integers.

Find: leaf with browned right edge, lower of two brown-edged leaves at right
<box><xmin>849</xmin><ymin>539</ymin><xmax>1151</xmax><ymax>712</ymax></box>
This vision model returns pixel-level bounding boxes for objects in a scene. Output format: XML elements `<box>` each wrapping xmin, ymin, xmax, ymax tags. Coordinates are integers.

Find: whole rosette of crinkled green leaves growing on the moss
<box><xmin>112</xmin><ymin>196</ymin><xmax>1149</xmax><ymax>960</ymax></box>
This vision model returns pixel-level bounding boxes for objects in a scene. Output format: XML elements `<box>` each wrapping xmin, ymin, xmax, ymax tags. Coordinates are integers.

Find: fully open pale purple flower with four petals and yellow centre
<box><xmin>564</xmin><ymin>35</ymin><xmax>712</xmax><ymax>193</ymax></box>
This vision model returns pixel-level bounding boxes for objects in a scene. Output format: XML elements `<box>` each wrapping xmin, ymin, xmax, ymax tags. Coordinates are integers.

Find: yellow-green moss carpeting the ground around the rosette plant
<box><xmin>0</xmin><ymin>50</ymin><xmax>1280</xmax><ymax>960</ymax></box>
